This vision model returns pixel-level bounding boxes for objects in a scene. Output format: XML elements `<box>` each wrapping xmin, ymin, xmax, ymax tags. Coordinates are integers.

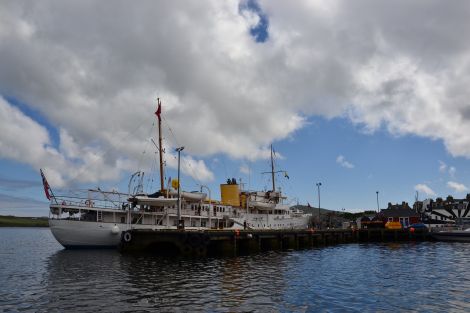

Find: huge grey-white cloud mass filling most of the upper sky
<box><xmin>0</xmin><ymin>0</ymin><xmax>470</xmax><ymax>185</ymax></box>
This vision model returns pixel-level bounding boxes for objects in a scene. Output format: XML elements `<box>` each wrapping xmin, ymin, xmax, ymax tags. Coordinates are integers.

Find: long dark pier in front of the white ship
<box><xmin>120</xmin><ymin>229</ymin><xmax>428</xmax><ymax>257</ymax></box>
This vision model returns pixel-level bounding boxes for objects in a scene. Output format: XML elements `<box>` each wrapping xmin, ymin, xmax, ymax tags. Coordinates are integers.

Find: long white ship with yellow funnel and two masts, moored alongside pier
<box><xmin>41</xmin><ymin>101</ymin><xmax>311</xmax><ymax>248</ymax></box>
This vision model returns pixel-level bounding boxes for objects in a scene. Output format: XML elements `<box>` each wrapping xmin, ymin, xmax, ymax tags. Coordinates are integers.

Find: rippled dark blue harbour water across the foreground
<box><xmin>0</xmin><ymin>228</ymin><xmax>470</xmax><ymax>312</ymax></box>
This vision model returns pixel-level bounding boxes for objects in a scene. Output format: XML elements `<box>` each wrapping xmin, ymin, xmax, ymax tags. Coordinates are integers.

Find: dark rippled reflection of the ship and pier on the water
<box><xmin>40</xmin><ymin>250</ymin><xmax>288</xmax><ymax>312</ymax></box>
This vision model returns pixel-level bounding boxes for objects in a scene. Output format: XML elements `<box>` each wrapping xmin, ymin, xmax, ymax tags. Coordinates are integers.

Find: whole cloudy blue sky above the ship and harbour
<box><xmin>0</xmin><ymin>0</ymin><xmax>470</xmax><ymax>216</ymax></box>
